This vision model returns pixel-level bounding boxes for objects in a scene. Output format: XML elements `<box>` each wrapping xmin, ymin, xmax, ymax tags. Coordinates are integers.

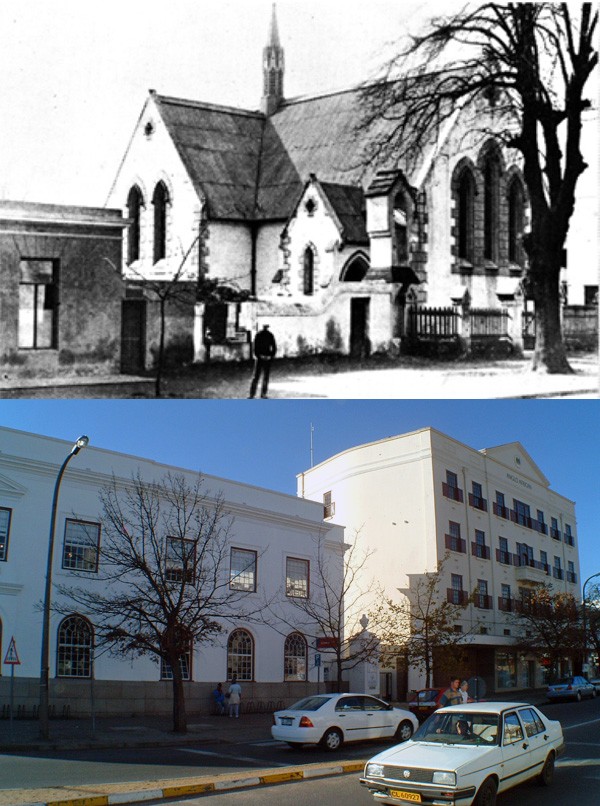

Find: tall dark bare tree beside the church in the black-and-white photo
<box><xmin>363</xmin><ymin>2</ymin><xmax>598</xmax><ymax>372</ymax></box>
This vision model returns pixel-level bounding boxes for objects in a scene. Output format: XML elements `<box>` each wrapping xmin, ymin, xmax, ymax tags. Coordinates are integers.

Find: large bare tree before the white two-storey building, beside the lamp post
<box><xmin>59</xmin><ymin>471</ymin><xmax>263</xmax><ymax>733</ymax></box>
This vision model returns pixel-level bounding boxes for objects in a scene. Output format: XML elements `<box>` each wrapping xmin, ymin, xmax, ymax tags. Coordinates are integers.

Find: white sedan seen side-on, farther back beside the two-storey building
<box><xmin>271</xmin><ymin>694</ymin><xmax>419</xmax><ymax>750</ymax></box>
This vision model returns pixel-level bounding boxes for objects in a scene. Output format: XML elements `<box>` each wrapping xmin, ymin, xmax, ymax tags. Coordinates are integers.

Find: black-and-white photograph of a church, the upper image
<box><xmin>0</xmin><ymin>0</ymin><xmax>599</xmax><ymax>405</ymax></box>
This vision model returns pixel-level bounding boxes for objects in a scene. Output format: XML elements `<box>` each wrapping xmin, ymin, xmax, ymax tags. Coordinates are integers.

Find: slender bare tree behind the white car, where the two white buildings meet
<box><xmin>271</xmin><ymin>533</ymin><xmax>379</xmax><ymax>691</ymax></box>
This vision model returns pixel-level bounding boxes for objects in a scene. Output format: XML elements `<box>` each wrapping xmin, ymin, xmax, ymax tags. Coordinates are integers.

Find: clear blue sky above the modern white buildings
<box><xmin>0</xmin><ymin>400</ymin><xmax>600</xmax><ymax>582</ymax></box>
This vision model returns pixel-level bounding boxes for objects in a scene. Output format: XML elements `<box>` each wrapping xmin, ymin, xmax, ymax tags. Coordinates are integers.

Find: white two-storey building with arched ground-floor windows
<box><xmin>0</xmin><ymin>428</ymin><xmax>345</xmax><ymax>715</ymax></box>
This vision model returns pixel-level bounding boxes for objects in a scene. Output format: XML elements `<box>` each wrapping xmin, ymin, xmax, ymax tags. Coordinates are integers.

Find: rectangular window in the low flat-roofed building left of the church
<box><xmin>18</xmin><ymin>258</ymin><xmax>58</xmax><ymax>350</ymax></box>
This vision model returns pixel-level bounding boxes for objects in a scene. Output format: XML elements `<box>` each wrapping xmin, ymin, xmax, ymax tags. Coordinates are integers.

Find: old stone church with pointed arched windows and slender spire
<box><xmin>108</xmin><ymin>6</ymin><xmax>528</xmax><ymax>368</ymax></box>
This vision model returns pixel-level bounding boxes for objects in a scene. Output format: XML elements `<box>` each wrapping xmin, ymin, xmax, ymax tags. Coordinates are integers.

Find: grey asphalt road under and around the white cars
<box><xmin>0</xmin><ymin>698</ymin><xmax>600</xmax><ymax>806</ymax></box>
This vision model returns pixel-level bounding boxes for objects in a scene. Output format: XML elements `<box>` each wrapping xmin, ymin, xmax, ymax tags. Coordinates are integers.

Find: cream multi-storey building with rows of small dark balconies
<box><xmin>298</xmin><ymin>428</ymin><xmax>580</xmax><ymax>697</ymax></box>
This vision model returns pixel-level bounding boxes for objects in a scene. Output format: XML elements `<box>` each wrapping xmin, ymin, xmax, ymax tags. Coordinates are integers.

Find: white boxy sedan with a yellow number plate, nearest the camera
<box><xmin>360</xmin><ymin>702</ymin><xmax>564</xmax><ymax>806</ymax></box>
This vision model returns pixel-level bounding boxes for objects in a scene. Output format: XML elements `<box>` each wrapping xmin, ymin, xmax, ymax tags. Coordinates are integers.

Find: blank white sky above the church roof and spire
<box><xmin>0</xmin><ymin>0</ymin><xmax>432</xmax><ymax>207</ymax></box>
